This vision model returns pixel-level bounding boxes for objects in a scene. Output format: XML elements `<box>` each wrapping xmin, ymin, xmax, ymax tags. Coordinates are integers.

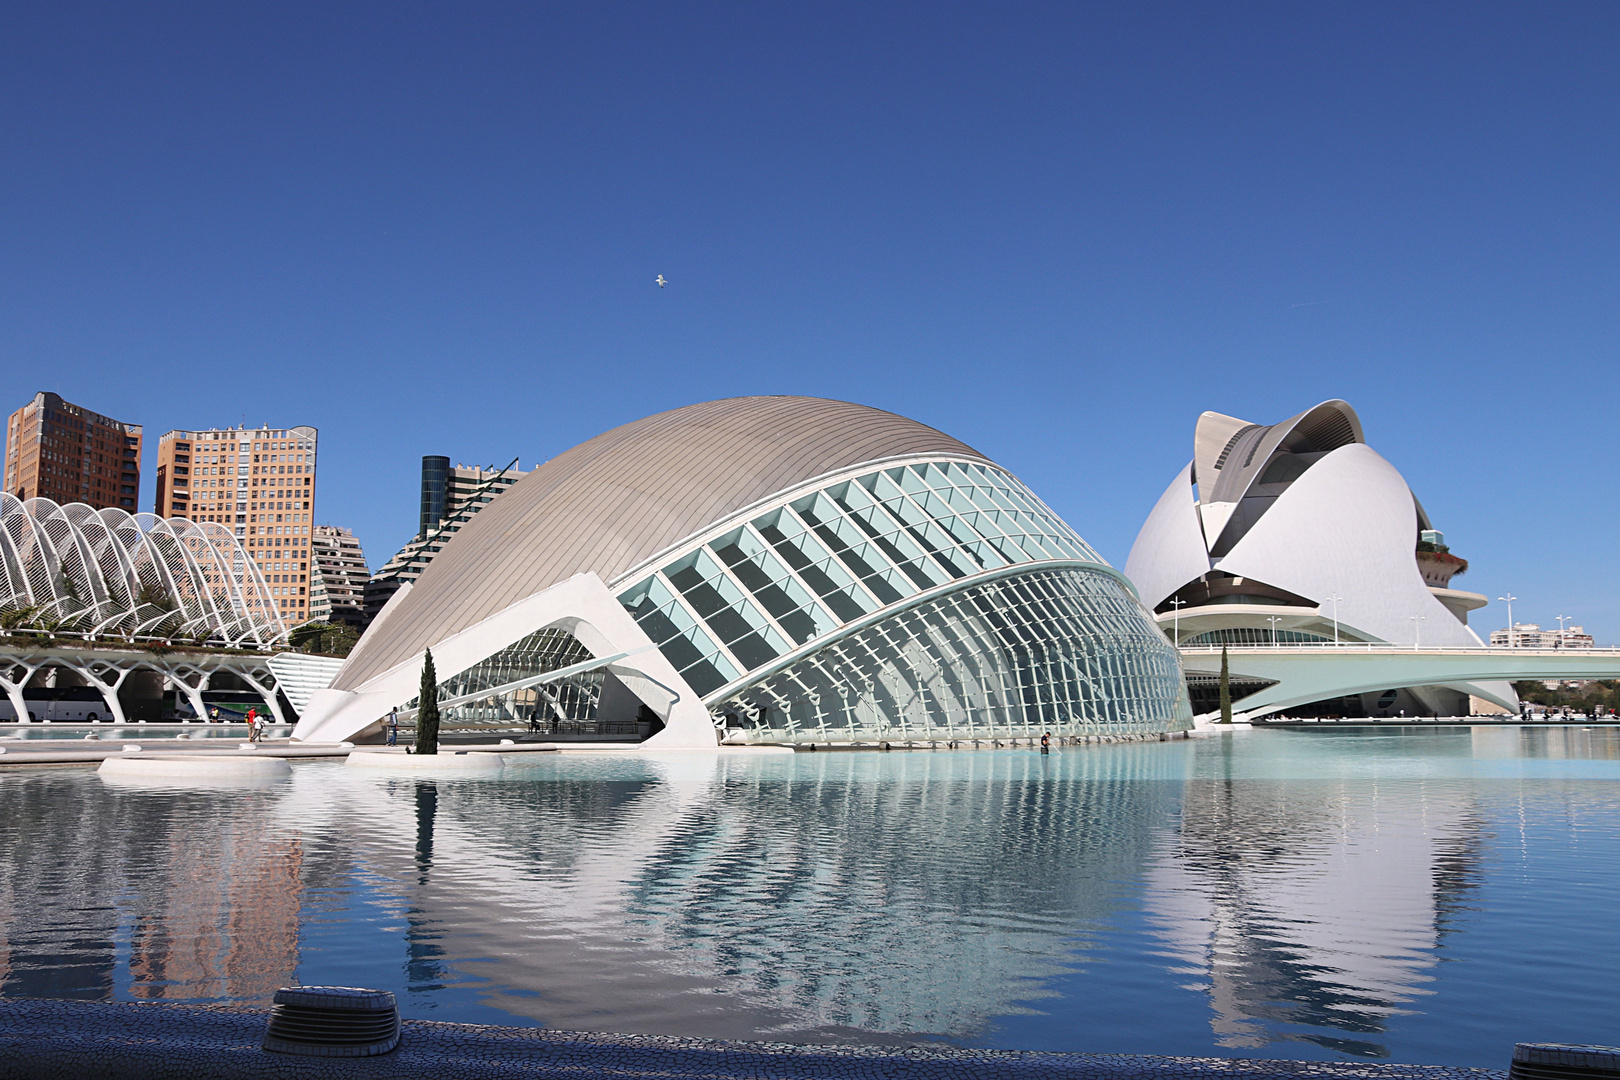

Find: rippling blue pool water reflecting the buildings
<box><xmin>0</xmin><ymin>729</ymin><xmax>1620</xmax><ymax>1067</ymax></box>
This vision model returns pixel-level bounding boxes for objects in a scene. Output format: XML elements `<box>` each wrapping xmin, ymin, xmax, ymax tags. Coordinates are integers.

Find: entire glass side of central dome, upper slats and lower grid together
<box><xmin>602</xmin><ymin>461</ymin><xmax>1192</xmax><ymax>742</ymax></box>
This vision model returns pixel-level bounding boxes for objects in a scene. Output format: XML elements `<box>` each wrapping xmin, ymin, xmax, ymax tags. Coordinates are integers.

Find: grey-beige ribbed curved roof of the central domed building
<box><xmin>334</xmin><ymin>397</ymin><xmax>988</xmax><ymax>690</ymax></box>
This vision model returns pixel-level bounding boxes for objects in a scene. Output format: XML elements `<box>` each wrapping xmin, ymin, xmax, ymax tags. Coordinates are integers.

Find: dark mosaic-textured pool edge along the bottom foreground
<box><xmin>0</xmin><ymin>1001</ymin><xmax>1507</xmax><ymax>1080</ymax></box>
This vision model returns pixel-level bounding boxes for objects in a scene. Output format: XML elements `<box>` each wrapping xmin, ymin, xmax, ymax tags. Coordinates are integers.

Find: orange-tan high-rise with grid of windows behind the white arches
<box><xmin>154</xmin><ymin>427</ymin><xmax>316</xmax><ymax>625</ymax></box>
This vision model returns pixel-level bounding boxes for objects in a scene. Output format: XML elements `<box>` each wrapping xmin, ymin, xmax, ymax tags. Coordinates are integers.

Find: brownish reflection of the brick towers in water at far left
<box><xmin>0</xmin><ymin>774</ymin><xmax>301</xmax><ymax>1004</ymax></box>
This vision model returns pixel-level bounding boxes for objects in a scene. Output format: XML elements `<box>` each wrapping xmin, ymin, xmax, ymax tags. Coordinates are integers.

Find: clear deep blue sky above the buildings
<box><xmin>0</xmin><ymin>0</ymin><xmax>1620</xmax><ymax>641</ymax></box>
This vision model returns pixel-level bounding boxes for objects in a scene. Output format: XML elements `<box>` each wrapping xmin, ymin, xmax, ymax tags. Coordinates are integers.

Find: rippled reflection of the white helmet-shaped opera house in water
<box><xmin>1145</xmin><ymin>735</ymin><xmax>1482</xmax><ymax>1057</ymax></box>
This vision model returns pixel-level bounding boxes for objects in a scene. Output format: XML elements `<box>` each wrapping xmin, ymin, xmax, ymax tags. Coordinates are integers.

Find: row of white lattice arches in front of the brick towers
<box><xmin>0</xmin><ymin>492</ymin><xmax>288</xmax><ymax>648</ymax></box>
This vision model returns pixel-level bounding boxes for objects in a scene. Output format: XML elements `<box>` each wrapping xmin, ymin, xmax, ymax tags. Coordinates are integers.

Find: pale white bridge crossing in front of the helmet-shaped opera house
<box><xmin>1181</xmin><ymin>641</ymin><xmax>1620</xmax><ymax>717</ymax></box>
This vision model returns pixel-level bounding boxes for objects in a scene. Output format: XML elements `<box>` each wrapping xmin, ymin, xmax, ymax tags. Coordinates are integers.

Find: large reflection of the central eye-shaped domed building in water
<box><xmin>288</xmin><ymin>748</ymin><xmax>1179</xmax><ymax>1038</ymax></box>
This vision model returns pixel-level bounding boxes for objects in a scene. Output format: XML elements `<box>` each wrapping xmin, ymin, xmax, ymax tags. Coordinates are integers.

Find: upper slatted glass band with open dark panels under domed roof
<box><xmin>619</xmin><ymin>461</ymin><xmax>1103</xmax><ymax>696</ymax></box>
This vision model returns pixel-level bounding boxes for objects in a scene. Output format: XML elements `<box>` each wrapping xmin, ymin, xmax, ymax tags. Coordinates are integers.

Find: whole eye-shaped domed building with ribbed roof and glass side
<box><xmin>295</xmin><ymin>397</ymin><xmax>1192</xmax><ymax>746</ymax></box>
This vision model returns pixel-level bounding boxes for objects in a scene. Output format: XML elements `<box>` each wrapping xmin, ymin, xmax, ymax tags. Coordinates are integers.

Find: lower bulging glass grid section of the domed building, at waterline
<box><xmin>711</xmin><ymin>567</ymin><xmax>1192</xmax><ymax>743</ymax></box>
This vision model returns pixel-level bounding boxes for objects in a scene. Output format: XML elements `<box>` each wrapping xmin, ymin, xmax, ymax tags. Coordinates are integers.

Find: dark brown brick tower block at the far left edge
<box><xmin>5</xmin><ymin>390</ymin><xmax>141</xmax><ymax>513</ymax></box>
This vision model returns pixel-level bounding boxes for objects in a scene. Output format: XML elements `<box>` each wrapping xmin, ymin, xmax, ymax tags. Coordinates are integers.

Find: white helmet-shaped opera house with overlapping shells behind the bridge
<box><xmin>1126</xmin><ymin>400</ymin><xmax>1518</xmax><ymax>711</ymax></box>
